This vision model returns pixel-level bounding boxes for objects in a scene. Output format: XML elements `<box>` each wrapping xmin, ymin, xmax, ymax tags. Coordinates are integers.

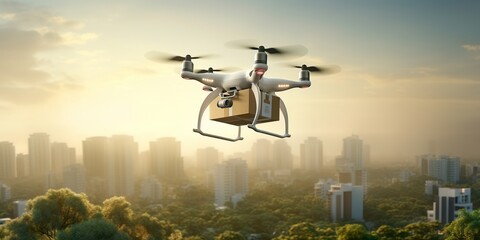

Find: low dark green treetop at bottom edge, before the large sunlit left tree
<box><xmin>57</xmin><ymin>218</ymin><xmax>131</xmax><ymax>240</ymax></box>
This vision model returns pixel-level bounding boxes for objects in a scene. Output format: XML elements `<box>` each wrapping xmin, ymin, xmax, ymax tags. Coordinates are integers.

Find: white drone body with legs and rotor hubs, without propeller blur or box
<box><xmin>149</xmin><ymin>46</ymin><xmax>334</xmax><ymax>142</ymax></box>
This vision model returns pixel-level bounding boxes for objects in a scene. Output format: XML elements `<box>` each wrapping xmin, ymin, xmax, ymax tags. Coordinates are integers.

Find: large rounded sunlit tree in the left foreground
<box><xmin>7</xmin><ymin>188</ymin><xmax>94</xmax><ymax>239</ymax></box>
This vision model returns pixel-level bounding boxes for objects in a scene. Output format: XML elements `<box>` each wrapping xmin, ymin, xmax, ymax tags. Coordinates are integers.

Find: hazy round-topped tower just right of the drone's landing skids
<box><xmin>300</xmin><ymin>137</ymin><xmax>323</xmax><ymax>172</ymax></box>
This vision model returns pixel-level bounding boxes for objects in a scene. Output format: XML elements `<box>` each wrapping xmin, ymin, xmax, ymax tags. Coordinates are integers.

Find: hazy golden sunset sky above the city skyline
<box><xmin>0</xmin><ymin>0</ymin><xmax>480</xmax><ymax>161</ymax></box>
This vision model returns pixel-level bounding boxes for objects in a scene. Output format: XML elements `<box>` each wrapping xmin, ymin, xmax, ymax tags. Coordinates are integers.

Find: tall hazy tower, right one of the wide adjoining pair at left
<box><xmin>108</xmin><ymin>135</ymin><xmax>138</xmax><ymax>196</ymax></box>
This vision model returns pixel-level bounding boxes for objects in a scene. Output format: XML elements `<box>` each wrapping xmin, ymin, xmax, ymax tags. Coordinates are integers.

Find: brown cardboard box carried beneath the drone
<box><xmin>210</xmin><ymin>89</ymin><xmax>280</xmax><ymax>126</ymax></box>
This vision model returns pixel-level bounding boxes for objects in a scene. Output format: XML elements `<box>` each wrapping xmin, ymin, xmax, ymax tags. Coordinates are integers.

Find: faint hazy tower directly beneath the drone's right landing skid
<box><xmin>249</xmin><ymin>139</ymin><xmax>273</xmax><ymax>170</ymax></box>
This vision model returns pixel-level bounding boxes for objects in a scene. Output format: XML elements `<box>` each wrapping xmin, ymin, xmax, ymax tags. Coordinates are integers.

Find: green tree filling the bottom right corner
<box><xmin>445</xmin><ymin>209</ymin><xmax>480</xmax><ymax>240</ymax></box>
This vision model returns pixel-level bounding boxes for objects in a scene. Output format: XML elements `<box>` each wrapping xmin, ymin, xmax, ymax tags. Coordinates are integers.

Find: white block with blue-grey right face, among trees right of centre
<box><xmin>328</xmin><ymin>184</ymin><xmax>363</xmax><ymax>222</ymax></box>
